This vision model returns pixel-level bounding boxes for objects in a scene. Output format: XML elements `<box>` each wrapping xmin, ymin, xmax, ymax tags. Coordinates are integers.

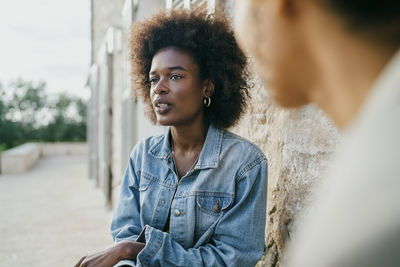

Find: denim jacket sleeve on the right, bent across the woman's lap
<box><xmin>137</xmin><ymin>158</ymin><xmax>267</xmax><ymax>267</ymax></box>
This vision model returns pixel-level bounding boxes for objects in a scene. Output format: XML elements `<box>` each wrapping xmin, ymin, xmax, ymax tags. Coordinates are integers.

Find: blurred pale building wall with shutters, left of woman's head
<box><xmin>88</xmin><ymin>0</ymin><xmax>165</xmax><ymax>207</ymax></box>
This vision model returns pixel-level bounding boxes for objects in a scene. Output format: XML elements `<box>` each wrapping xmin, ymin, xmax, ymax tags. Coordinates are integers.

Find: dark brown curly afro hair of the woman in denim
<box><xmin>131</xmin><ymin>9</ymin><xmax>249</xmax><ymax>128</ymax></box>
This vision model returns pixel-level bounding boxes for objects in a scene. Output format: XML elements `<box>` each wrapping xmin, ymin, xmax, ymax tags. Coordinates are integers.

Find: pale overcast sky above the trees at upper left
<box><xmin>0</xmin><ymin>0</ymin><xmax>90</xmax><ymax>96</ymax></box>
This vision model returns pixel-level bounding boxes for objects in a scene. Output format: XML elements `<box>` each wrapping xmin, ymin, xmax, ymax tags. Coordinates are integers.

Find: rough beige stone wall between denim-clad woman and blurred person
<box><xmin>231</xmin><ymin>65</ymin><xmax>338</xmax><ymax>266</ymax></box>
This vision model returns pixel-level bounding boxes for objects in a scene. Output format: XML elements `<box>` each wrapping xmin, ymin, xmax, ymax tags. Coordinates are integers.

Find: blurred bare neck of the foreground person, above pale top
<box><xmin>304</xmin><ymin>2</ymin><xmax>397</xmax><ymax>129</ymax></box>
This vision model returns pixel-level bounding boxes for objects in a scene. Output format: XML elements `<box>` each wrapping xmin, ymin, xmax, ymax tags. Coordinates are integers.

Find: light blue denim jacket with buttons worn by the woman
<box><xmin>111</xmin><ymin>125</ymin><xmax>267</xmax><ymax>267</ymax></box>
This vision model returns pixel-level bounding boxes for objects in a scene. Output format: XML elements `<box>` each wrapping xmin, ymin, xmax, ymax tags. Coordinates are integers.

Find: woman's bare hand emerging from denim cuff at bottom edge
<box><xmin>75</xmin><ymin>241</ymin><xmax>145</xmax><ymax>267</ymax></box>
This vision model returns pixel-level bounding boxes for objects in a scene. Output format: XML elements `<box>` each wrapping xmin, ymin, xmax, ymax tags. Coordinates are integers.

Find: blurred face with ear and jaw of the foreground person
<box><xmin>234</xmin><ymin>0</ymin><xmax>318</xmax><ymax>107</ymax></box>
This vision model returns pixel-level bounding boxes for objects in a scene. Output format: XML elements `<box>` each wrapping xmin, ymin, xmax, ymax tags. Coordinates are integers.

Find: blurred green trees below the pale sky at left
<box><xmin>0</xmin><ymin>79</ymin><xmax>86</xmax><ymax>152</ymax></box>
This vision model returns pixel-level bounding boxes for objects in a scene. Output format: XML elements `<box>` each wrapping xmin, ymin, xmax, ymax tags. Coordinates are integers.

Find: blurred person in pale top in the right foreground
<box><xmin>235</xmin><ymin>0</ymin><xmax>400</xmax><ymax>267</ymax></box>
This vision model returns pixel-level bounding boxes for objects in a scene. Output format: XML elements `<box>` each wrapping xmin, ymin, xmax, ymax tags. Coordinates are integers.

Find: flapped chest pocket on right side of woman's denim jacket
<box><xmin>196</xmin><ymin>193</ymin><xmax>233</xmax><ymax>239</ymax></box>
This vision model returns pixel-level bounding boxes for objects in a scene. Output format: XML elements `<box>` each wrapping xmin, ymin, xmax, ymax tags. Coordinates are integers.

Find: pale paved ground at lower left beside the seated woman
<box><xmin>0</xmin><ymin>156</ymin><xmax>112</xmax><ymax>267</ymax></box>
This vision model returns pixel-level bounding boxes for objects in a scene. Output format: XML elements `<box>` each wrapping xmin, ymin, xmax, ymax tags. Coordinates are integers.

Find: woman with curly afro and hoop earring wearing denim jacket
<box><xmin>77</xmin><ymin>10</ymin><xmax>267</xmax><ymax>267</ymax></box>
